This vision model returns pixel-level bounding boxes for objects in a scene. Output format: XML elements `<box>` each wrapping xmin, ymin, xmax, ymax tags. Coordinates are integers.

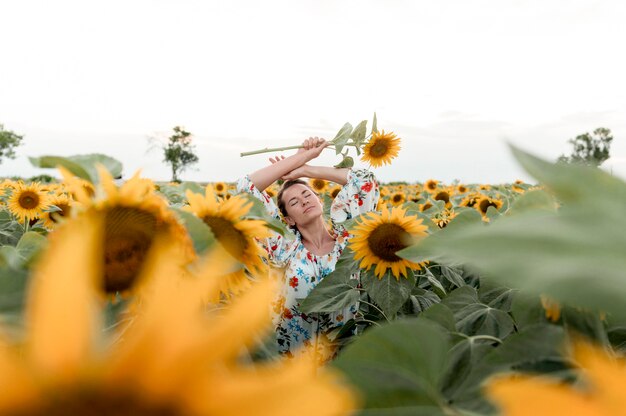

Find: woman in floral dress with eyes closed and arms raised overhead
<box><xmin>237</xmin><ymin>137</ymin><xmax>379</xmax><ymax>356</ymax></box>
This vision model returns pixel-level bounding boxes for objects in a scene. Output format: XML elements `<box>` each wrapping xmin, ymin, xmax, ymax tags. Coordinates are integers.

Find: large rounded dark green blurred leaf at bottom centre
<box><xmin>333</xmin><ymin>319</ymin><xmax>449</xmax><ymax>414</ymax></box>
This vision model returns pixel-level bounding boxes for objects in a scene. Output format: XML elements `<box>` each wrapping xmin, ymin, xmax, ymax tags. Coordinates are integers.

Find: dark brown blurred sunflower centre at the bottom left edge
<box><xmin>3</xmin><ymin>389</ymin><xmax>184</xmax><ymax>416</ymax></box>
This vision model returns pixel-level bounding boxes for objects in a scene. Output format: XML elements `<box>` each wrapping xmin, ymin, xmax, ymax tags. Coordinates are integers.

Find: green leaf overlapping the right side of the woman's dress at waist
<box><xmin>300</xmin><ymin>255</ymin><xmax>359</xmax><ymax>313</ymax></box>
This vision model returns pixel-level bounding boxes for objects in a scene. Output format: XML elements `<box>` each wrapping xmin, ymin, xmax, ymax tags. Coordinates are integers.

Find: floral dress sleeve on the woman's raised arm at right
<box><xmin>330</xmin><ymin>169</ymin><xmax>380</xmax><ymax>225</ymax></box>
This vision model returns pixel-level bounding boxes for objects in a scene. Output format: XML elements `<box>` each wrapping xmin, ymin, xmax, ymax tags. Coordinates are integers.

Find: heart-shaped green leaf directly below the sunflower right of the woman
<box><xmin>361</xmin><ymin>270</ymin><xmax>417</xmax><ymax>318</ymax></box>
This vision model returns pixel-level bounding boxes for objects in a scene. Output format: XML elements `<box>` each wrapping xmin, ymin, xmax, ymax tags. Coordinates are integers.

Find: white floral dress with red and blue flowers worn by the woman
<box><xmin>237</xmin><ymin>169</ymin><xmax>380</xmax><ymax>356</ymax></box>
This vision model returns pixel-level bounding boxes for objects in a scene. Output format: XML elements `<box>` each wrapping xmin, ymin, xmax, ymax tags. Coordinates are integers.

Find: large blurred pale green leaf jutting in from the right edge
<box><xmin>398</xmin><ymin>146</ymin><xmax>626</xmax><ymax>320</ymax></box>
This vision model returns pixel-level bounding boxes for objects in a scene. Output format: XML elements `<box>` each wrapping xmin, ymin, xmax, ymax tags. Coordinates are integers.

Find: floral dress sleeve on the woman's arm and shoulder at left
<box><xmin>237</xmin><ymin>175</ymin><xmax>294</xmax><ymax>267</ymax></box>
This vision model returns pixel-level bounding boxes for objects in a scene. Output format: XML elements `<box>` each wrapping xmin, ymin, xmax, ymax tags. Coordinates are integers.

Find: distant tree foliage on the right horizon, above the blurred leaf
<box><xmin>558</xmin><ymin>127</ymin><xmax>613</xmax><ymax>167</ymax></box>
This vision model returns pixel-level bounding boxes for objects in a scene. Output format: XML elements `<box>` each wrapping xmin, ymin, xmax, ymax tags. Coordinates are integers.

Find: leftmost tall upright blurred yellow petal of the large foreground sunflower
<box><xmin>26</xmin><ymin>215</ymin><xmax>103</xmax><ymax>377</ymax></box>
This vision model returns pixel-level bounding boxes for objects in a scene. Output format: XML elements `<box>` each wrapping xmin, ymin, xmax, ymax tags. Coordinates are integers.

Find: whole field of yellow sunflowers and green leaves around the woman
<box><xmin>0</xmin><ymin>125</ymin><xmax>626</xmax><ymax>416</ymax></box>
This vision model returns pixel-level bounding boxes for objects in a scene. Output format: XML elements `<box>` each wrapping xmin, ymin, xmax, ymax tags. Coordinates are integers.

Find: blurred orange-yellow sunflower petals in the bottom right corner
<box><xmin>487</xmin><ymin>342</ymin><xmax>626</xmax><ymax>416</ymax></box>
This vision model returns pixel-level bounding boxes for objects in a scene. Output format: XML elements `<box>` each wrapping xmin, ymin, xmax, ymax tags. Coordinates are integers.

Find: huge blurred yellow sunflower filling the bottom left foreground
<box><xmin>0</xmin><ymin>215</ymin><xmax>355</xmax><ymax>416</ymax></box>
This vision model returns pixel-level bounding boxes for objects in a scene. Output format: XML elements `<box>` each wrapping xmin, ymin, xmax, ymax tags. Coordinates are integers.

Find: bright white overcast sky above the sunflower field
<box><xmin>0</xmin><ymin>0</ymin><xmax>626</xmax><ymax>183</ymax></box>
